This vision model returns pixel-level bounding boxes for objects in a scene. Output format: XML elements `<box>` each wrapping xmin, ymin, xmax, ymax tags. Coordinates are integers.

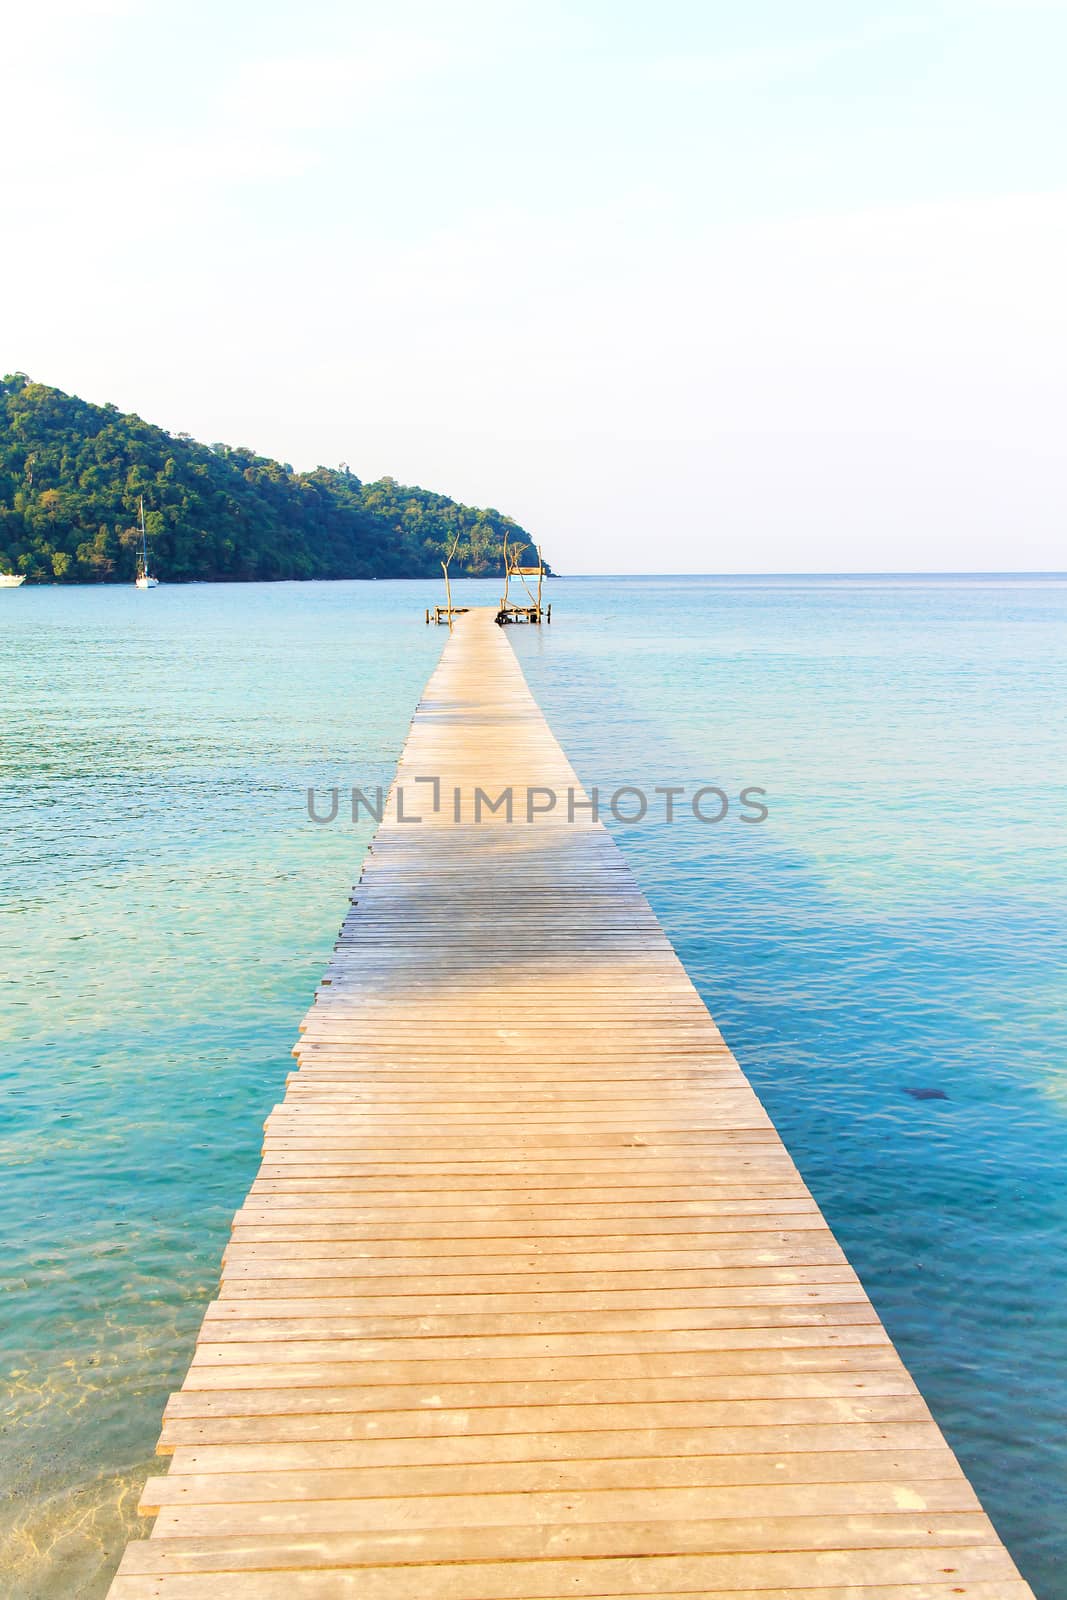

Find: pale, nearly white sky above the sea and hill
<box><xmin>0</xmin><ymin>0</ymin><xmax>1067</xmax><ymax>573</ymax></box>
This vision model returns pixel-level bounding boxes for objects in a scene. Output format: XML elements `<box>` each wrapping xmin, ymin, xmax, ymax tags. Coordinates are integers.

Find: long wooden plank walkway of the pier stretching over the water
<box><xmin>110</xmin><ymin>610</ymin><xmax>1030</xmax><ymax>1600</ymax></box>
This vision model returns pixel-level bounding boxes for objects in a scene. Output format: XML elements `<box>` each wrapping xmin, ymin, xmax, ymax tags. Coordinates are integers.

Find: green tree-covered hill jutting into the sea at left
<box><xmin>0</xmin><ymin>373</ymin><xmax>543</xmax><ymax>582</ymax></box>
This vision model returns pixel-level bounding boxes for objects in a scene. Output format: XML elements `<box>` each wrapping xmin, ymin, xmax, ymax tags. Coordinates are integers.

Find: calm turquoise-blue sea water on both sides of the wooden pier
<box><xmin>0</xmin><ymin>579</ymin><xmax>1067</xmax><ymax>1600</ymax></box>
